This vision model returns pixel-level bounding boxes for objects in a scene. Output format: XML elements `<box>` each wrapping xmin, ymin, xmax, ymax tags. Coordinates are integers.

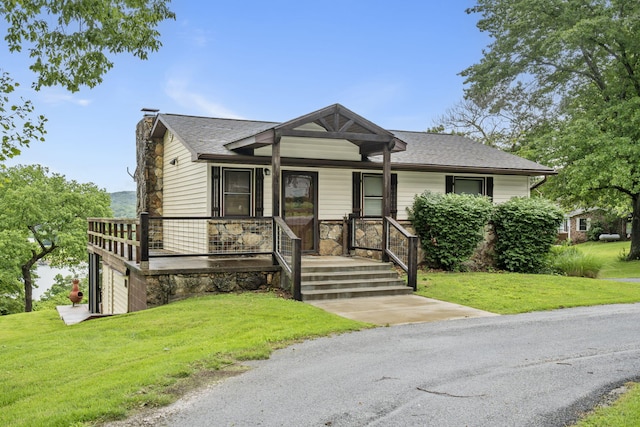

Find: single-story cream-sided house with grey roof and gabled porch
<box><xmin>89</xmin><ymin>104</ymin><xmax>555</xmax><ymax>311</ymax></box>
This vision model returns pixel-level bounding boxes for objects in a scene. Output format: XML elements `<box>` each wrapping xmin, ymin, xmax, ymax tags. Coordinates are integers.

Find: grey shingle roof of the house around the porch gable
<box><xmin>151</xmin><ymin>107</ymin><xmax>556</xmax><ymax>175</ymax></box>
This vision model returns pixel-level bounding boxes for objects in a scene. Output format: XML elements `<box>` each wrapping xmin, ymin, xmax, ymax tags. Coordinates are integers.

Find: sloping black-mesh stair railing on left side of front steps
<box><xmin>273</xmin><ymin>216</ymin><xmax>302</xmax><ymax>301</ymax></box>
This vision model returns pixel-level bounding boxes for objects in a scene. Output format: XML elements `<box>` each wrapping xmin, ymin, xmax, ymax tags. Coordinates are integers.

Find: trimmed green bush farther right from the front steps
<box><xmin>493</xmin><ymin>197</ymin><xmax>563</xmax><ymax>273</ymax></box>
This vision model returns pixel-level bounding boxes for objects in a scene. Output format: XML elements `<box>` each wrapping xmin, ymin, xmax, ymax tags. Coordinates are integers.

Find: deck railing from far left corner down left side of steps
<box><xmin>88</xmin><ymin>213</ymin><xmax>302</xmax><ymax>300</ymax></box>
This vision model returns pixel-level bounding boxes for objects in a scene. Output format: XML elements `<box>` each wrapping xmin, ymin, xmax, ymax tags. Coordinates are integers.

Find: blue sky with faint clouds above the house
<box><xmin>0</xmin><ymin>0</ymin><xmax>489</xmax><ymax>192</ymax></box>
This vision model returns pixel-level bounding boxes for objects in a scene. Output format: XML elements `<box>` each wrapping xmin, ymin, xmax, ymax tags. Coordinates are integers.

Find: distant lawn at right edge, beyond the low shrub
<box><xmin>575</xmin><ymin>242</ymin><xmax>640</xmax><ymax>279</ymax></box>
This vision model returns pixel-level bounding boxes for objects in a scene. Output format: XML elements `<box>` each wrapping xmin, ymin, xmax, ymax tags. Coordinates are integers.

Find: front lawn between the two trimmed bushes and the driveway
<box><xmin>417</xmin><ymin>273</ymin><xmax>640</xmax><ymax>314</ymax></box>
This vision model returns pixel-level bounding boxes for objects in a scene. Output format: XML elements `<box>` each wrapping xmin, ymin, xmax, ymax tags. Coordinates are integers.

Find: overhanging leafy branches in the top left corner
<box><xmin>0</xmin><ymin>0</ymin><xmax>175</xmax><ymax>164</ymax></box>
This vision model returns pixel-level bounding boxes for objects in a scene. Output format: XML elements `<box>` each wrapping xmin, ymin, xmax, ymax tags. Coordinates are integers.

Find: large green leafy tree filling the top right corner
<box><xmin>461</xmin><ymin>0</ymin><xmax>640</xmax><ymax>259</ymax></box>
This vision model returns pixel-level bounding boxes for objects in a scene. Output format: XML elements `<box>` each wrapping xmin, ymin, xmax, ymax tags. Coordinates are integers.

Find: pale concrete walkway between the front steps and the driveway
<box><xmin>308</xmin><ymin>295</ymin><xmax>498</xmax><ymax>326</ymax></box>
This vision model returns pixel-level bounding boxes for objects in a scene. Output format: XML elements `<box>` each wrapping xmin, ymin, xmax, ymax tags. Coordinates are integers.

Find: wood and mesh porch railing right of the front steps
<box><xmin>349</xmin><ymin>216</ymin><xmax>418</xmax><ymax>291</ymax></box>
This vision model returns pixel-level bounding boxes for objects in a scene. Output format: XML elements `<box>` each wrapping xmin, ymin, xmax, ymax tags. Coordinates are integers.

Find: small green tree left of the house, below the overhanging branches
<box><xmin>0</xmin><ymin>166</ymin><xmax>111</xmax><ymax>312</ymax></box>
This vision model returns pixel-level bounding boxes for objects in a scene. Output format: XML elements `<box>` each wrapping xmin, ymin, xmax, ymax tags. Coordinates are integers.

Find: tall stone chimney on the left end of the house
<box><xmin>134</xmin><ymin>116</ymin><xmax>164</xmax><ymax>216</ymax></box>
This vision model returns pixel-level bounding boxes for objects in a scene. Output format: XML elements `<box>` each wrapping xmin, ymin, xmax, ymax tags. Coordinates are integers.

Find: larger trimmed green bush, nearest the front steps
<box><xmin>409</xmin><ymin>192</ymin><xmax>493</xmax><ymax>271</ymax></box>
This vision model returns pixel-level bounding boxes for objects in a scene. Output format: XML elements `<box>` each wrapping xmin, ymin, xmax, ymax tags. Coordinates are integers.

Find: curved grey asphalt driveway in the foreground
<box><xmin>122</xmin><ymin>304</ymin><xmax>640</xmax><ymax>427</ymax></box>
